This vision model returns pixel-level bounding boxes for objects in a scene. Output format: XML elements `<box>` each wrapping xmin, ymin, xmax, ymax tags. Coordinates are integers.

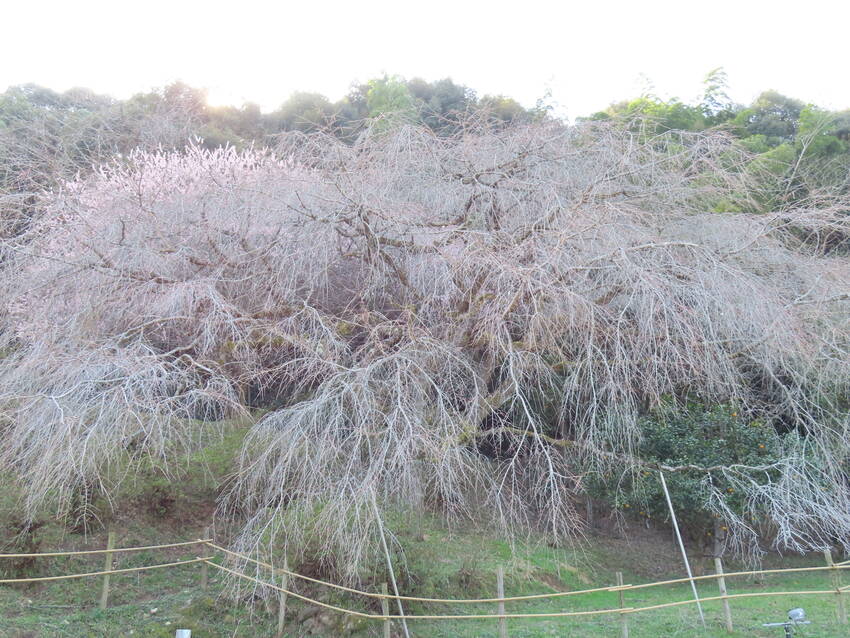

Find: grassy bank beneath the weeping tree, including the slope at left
<box><xmin>0</xmin><ymin>429</ymin><xmax>850</xmax><ymax>638</ymax></box>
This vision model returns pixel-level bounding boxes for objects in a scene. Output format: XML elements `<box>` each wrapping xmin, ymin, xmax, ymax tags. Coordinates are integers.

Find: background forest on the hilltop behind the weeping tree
<box><xmin>6</xmin><ymin>69</ymin><xmax>850</xmax><ymax>218</ymax></box>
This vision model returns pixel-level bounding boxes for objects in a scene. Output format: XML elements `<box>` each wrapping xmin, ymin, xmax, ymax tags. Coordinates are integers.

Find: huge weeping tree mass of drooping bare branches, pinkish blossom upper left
<box><xmin>0</xmin><ymin>116</ymin><xmax>850</xmax><ymax>577</ymax></box>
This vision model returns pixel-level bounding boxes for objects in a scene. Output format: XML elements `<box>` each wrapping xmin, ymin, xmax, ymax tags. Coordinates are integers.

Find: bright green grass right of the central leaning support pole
<box><xmin>388</xmin><ymin>537</ymin><xmax>850</xmax><ymax>638</ymax></box>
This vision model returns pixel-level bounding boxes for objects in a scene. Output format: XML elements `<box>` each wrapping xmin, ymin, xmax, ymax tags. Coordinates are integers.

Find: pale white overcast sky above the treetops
<box><xmin>0</xmin><ymin>0</ymin><xmax>850</xmax><ymax>118</ymax></box>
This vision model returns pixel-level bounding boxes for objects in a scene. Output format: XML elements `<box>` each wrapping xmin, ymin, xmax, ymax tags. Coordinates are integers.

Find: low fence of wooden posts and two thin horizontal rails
<box><xmin>0</xmin><ymin>533</ymin><xmax>850</xmax><ymax>637</ymax></box>
